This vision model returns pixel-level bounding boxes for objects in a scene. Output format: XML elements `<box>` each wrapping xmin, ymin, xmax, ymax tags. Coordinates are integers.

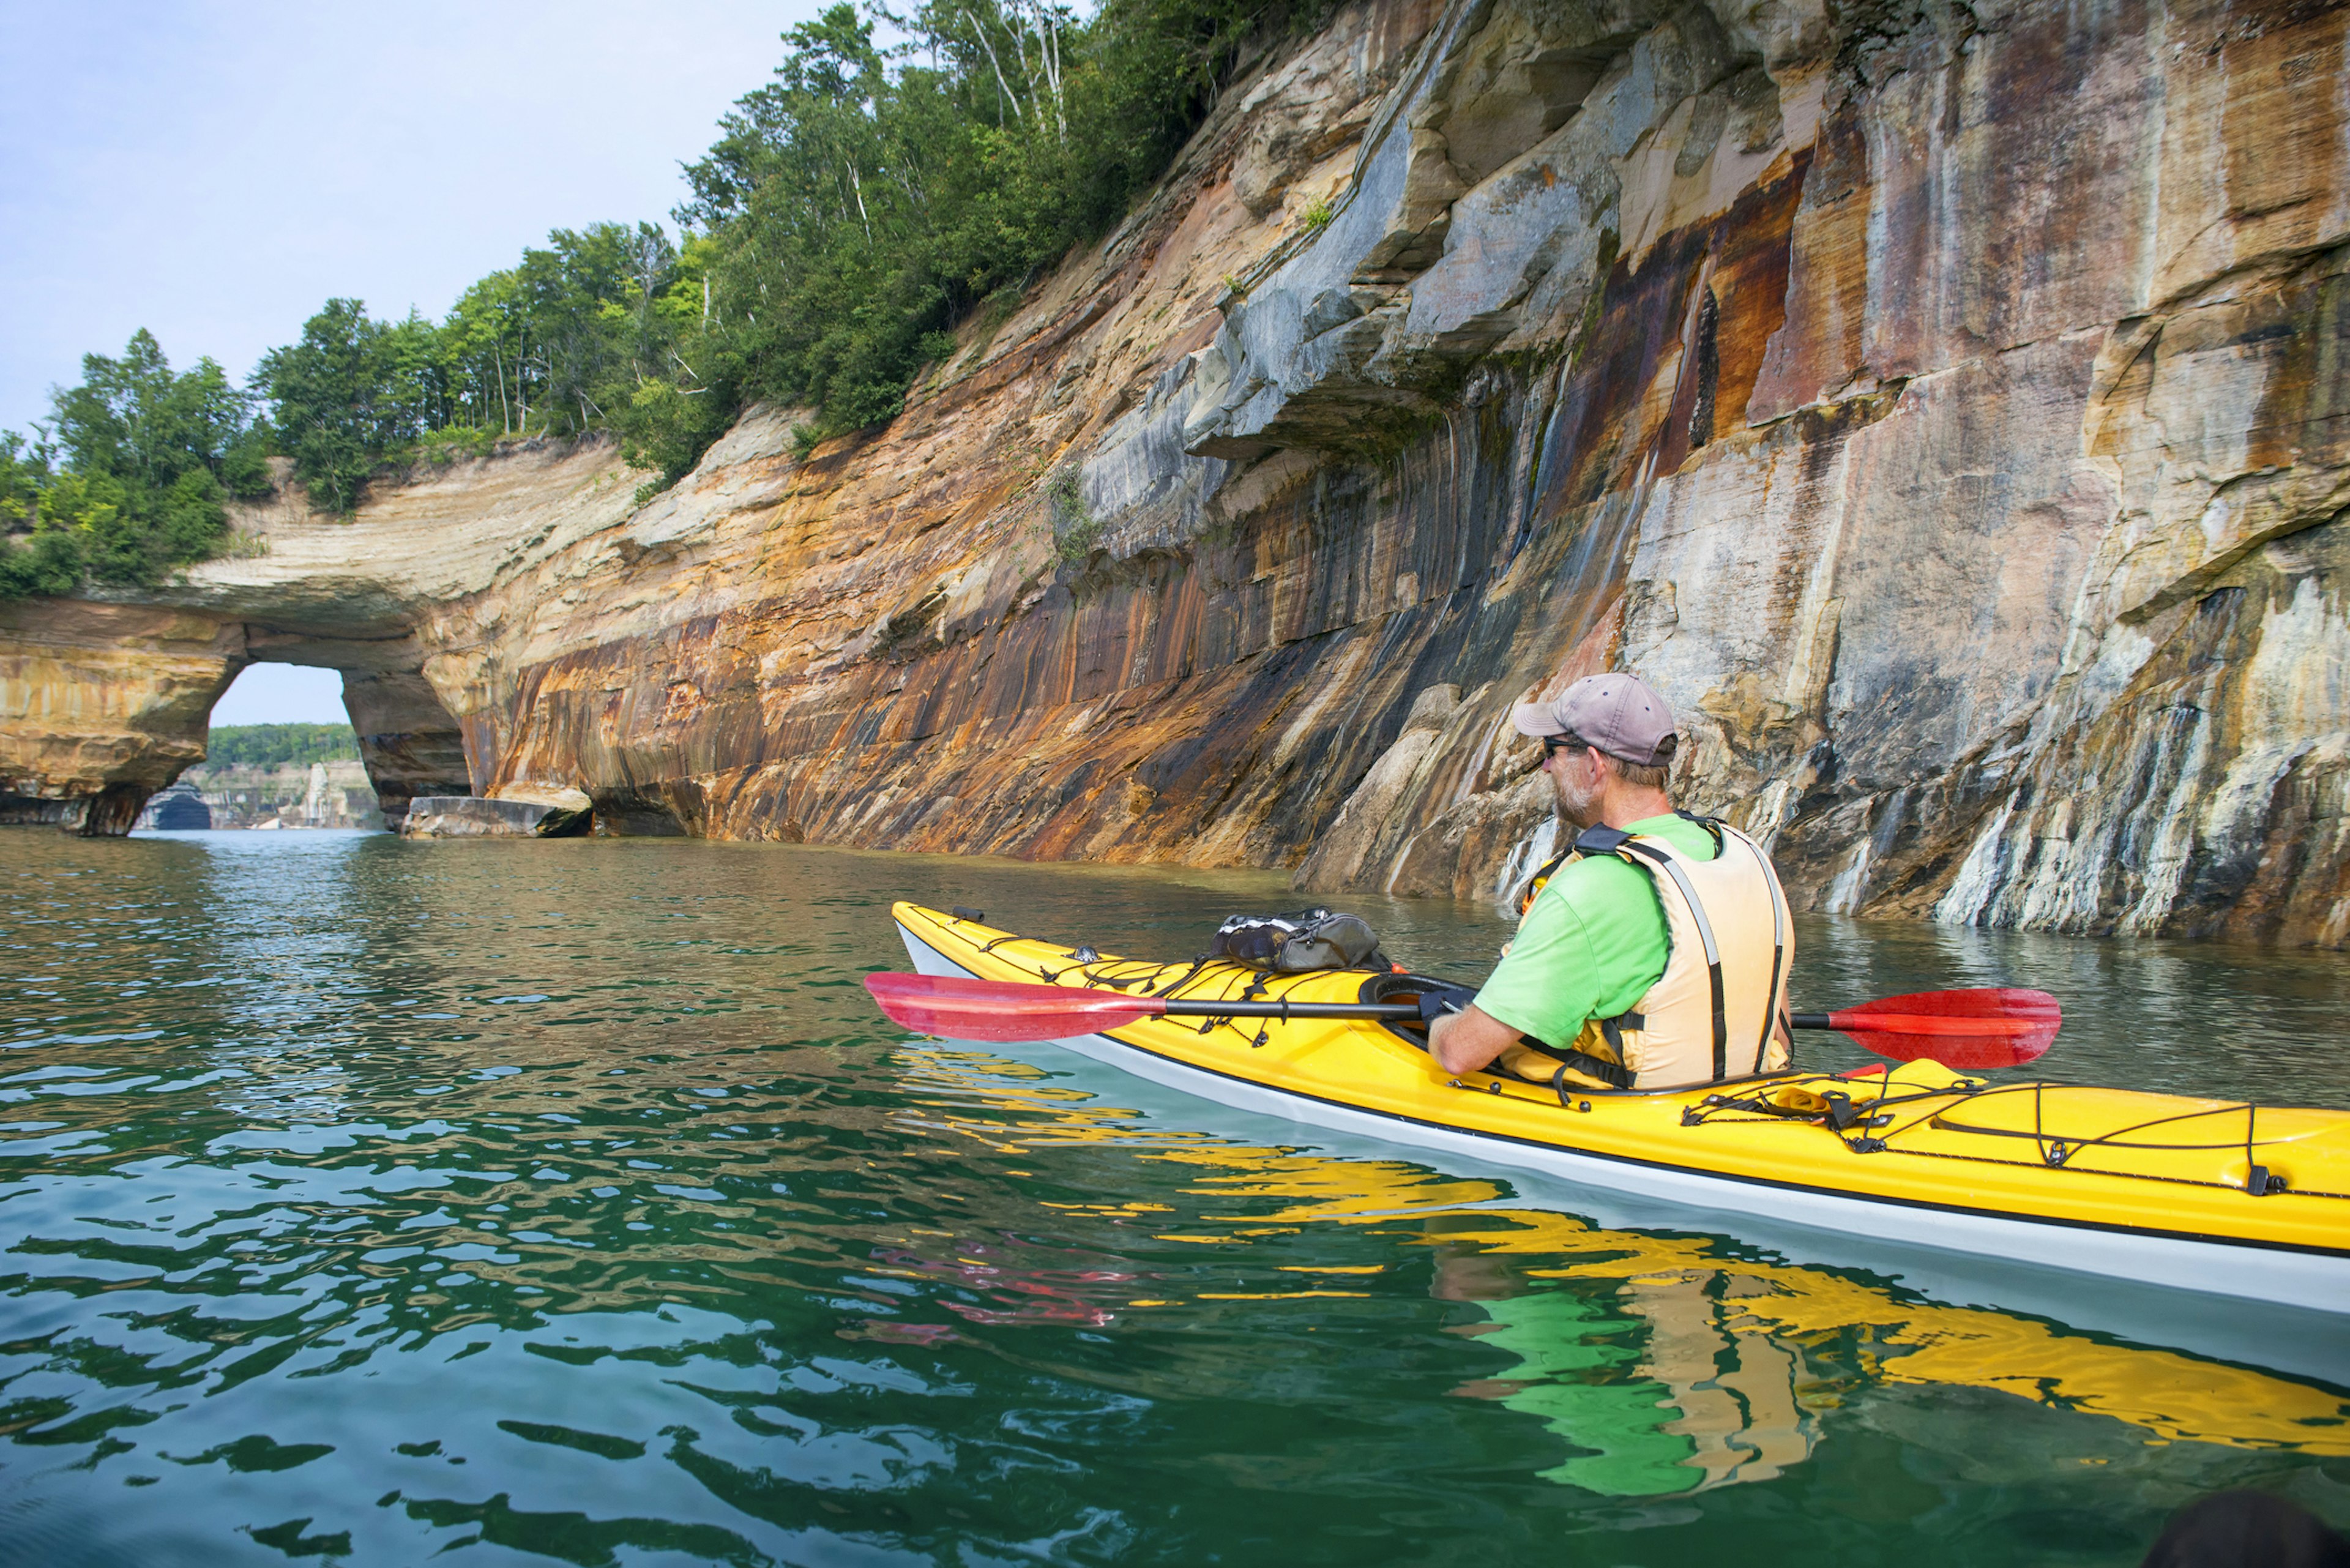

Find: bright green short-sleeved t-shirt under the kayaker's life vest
<box><xmin>1476</xmin><ymin>816</ymin><xmax>1713</xmax><ymax>1046</ymax></box>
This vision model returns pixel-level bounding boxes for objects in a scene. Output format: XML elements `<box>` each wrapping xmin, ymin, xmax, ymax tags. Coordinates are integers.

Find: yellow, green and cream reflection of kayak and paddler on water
<box><xmin>905</xmin><ymin>1048</ymin><xmax>2350</xmax><ymax>1495</ymax></box>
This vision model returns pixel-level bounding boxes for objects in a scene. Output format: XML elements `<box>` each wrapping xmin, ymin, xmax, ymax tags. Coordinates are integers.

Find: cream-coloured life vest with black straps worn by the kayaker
<box><xmin>1499</xmin><ymin>811</ymin><xmax>1796</xmax><ymax>1088</ymax></box>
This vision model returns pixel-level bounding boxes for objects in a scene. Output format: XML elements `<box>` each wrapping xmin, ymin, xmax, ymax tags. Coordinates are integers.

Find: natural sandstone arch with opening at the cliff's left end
<box><xmin>0</xmin><ymin>442</ymin><xmax>641</xmax><ymax>837</ymax></box>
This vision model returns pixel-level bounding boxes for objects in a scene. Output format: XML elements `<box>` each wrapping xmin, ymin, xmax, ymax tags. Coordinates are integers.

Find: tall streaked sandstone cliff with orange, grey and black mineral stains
<box><xmin>0</xmin><ymin>0</ymin><xmax>2350</xmax><ymax>945</ymax></box>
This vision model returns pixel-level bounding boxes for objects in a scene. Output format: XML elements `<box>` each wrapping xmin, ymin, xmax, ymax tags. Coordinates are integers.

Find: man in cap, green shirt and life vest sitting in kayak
<box><xmin>1429</xmin><ymin>673</ymin><xmax>1796</xmax><ymax>1088</ymax></box>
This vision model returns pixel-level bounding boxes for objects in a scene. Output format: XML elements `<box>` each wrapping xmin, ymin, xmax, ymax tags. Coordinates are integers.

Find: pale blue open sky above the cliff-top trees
<box><xmin>0</xmin><ymin>0</ymin><xmax>820</xmax><ymax>430</ymax></box>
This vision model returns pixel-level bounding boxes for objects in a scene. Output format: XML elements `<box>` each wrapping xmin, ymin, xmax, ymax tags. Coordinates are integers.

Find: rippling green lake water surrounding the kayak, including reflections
<box><xmin>0</xmin><ymin>830</ymin><xmax>2350</xmax><ymax>1568</ymax></box>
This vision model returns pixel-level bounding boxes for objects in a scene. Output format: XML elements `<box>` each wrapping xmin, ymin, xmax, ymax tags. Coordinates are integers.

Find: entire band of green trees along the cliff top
<box><xmin>0</xmin><ymin>0</ymin><xmax>1330</xmax><ymax>599</ymax></box>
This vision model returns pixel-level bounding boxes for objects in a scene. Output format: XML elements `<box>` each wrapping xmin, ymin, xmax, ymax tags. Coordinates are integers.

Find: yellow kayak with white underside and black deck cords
<box><xmin>890</xmin><ymin>903</ymin><xmax>2350</xmax><ymax>1312</ymax></box>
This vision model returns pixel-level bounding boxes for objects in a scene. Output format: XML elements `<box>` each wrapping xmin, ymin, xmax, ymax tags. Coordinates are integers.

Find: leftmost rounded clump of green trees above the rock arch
<box><xmin>0</xmin><ymin>332</ymin><xmax>270</xmax><ymax>599</ymax></box>
